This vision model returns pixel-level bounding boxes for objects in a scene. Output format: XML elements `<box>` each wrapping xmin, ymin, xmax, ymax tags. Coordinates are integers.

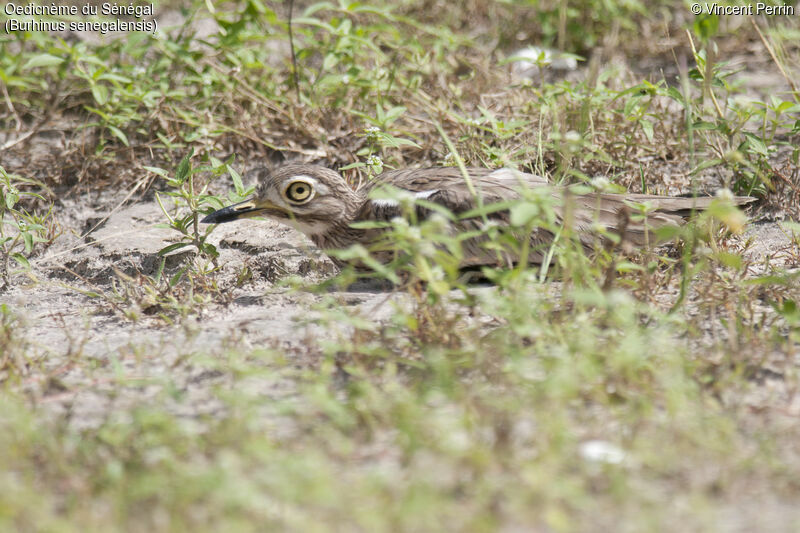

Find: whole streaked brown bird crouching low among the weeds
<box><xmin>201</xmin><ymin>164</ymin><xmax>755</xmax><ymax>270</ymax></box>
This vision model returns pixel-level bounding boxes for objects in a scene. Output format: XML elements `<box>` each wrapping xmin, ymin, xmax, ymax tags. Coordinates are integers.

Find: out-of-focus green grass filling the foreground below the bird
<box><xmin>0</xmin><ymin>283</ymin><xmax>798</xmax><ymax>530</ymax></box>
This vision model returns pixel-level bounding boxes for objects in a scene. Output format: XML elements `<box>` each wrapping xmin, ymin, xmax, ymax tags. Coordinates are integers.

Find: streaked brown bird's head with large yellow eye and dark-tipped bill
<box><xmin>202</xmin><ymin>165</ymin><xmax>360</xmax><ymax>235</ymax></box>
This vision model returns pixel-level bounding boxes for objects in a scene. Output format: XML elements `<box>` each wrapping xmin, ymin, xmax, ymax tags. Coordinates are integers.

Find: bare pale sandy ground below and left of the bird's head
<box><xmin>2</xmin><ymin>188</ymin><xmax>412</xmax><ymax>427</ymax></box>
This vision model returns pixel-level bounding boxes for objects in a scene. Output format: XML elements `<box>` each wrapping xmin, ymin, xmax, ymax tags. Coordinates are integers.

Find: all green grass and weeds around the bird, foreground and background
<box><xmin>0</xmin><ymin>0</ymin><xmax>800</xmax><ymax>531</ymax></box>
